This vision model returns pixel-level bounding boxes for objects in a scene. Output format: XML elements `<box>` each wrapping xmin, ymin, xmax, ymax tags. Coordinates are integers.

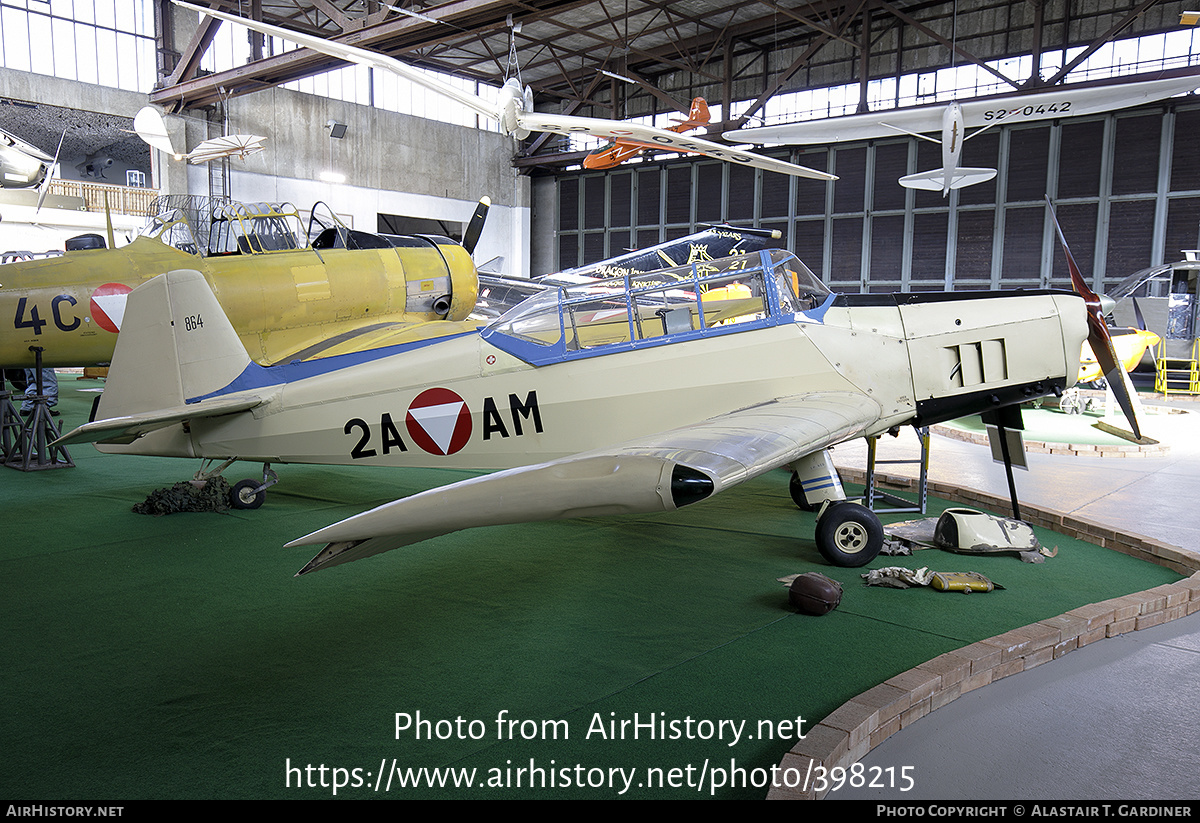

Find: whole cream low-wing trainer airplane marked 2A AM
<box><xmin>62</xmin><ymin>199</ymin><xmax>1136</xmax><ymax>573</ymax></box>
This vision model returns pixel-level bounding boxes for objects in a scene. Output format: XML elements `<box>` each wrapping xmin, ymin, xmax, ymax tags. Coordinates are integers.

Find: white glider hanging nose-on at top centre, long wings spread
<box><xmin>173</xmin><ymin>0</ymin><xmax>836</xmax><ymax>180</ymax></box>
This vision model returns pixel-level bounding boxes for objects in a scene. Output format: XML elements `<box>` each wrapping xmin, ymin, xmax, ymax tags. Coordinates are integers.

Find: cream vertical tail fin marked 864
<box><xmin>97</xmin><ymin>269</ymin><xmax>251</xmax><ymax>419</ymax></box>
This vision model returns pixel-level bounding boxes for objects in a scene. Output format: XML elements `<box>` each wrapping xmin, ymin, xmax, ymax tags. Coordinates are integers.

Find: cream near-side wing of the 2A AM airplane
<box><xmin>288</xmin><ymin>391</ymin><xmax>881</xmax><ymax>575</ymax></box>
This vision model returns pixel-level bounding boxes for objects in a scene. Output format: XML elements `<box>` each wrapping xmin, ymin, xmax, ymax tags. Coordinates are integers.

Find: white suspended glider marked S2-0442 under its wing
<box><xmin>725</xmin><ymin>77</ymin><xmax>1200</xmax><ymax>196</ymax></box>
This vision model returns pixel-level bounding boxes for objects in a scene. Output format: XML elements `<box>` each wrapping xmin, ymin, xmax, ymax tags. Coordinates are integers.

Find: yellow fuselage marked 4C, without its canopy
<box><xmin>0</xmin><ymin>236</ymin><xmax>478</xmax><ymax>367</ymax></box>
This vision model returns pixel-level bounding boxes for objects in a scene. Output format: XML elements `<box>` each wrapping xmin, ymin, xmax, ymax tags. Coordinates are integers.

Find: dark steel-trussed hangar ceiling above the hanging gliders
<box><xmin>151</xmin><ymin>0</ymin><xmax>1184</xmax><ymax>164</ymax></box>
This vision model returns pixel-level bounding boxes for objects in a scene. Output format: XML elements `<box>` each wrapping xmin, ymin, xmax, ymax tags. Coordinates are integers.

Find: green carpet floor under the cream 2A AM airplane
<box><xmin>0</xmin><ymin>377</ymin><xmax>1178</xmax><ymax>800</ymax></box>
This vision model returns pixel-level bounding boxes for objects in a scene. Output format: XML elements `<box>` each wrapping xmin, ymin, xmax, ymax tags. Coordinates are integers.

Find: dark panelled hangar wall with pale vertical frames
<box><xmin>556</xmin><ymin>103</ymin><xmax>1200</xmax><ymax>292</ymax></box>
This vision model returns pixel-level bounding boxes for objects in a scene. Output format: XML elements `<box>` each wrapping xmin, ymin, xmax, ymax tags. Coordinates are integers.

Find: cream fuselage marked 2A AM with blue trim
<box><xmin>101</xmin><ymin>268</ymin><xmax>1086</xmax><ymax>470</ymax></box>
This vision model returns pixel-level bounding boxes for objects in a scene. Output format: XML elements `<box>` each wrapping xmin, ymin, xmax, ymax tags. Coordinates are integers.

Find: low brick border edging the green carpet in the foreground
<box><xmin>767</xmin><ymin>467</ymin><xmax>1200</xmax><ymax>800</ymax></box>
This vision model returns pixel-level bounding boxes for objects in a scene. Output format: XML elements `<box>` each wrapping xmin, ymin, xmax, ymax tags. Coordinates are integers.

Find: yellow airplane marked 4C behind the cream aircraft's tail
<box><xmin>0</xmin><ymin>198</ymin><xmax>487</xmax><ymax>368</ymax></box>
